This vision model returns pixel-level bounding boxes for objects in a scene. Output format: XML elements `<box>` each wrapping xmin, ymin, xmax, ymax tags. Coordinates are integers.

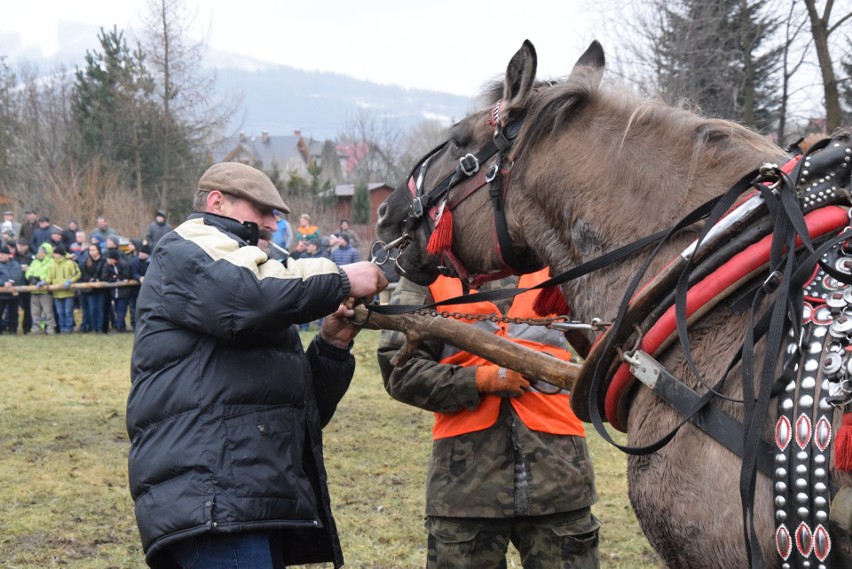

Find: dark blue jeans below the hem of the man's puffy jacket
<box><xmin>169</xmin><ymin>533</ymin><xmax>285</xmax><ymax>569</ymax></box>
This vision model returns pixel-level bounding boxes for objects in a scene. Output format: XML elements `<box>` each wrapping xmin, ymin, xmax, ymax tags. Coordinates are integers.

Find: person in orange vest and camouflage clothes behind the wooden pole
<box><xmin>378</xmin><ymin>269</ymin><xmax>600</xmax><ymax>569</ymax></box>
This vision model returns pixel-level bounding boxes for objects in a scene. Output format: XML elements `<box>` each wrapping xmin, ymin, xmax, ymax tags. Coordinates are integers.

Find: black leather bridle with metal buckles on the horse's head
<box><xmin>400</xmin><ymin>100</ymin><xmax>543</xmax><ymax>289</ymax></box>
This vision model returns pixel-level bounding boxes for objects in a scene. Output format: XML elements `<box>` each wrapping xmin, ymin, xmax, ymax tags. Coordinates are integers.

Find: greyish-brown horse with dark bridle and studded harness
<box><xmin>377</xmin><ymin>37</ymin><xmax>852</xmax><ymax>569</ymax></box>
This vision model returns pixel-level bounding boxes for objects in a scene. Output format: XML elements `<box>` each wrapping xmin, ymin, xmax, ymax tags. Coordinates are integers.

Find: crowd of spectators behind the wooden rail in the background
<box><xmin>0</xmin><ymin>209</ymin><xmax>398</xmax><ymax>335</ymax></box>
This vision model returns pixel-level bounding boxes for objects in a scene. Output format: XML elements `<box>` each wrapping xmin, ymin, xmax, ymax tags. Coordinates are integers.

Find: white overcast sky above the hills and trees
<box><xmin>0</xmin><ymin>0</ymin><xmax>619</xmax><ymax>96</ymax></box>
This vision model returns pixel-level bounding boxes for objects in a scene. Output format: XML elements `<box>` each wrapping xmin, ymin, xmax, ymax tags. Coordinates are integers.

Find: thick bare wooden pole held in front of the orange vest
<box><xmin>352</xmin><ymin>305</ymin><xmax>583</xmax><ymax>391</ymax></box>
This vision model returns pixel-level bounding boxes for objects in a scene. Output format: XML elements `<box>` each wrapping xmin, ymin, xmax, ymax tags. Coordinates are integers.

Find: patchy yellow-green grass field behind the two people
<box><xmin>0</xmin><ymin>331</ymin><xmax>659</xmax><ymax>569</ymax></box>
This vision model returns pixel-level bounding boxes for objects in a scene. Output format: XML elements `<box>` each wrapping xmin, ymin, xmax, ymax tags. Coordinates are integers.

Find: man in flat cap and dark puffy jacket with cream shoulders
<box><xmin>127</xmin><ymin>163</ymin><xmax>387</xmax><ymax>569</ymax></box>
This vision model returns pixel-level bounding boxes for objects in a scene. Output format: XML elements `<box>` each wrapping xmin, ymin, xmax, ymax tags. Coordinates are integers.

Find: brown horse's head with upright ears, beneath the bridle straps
<box><xmin>378</xmin><ymin>41</ymin><xmax>604</xmax><ymax>284</ymax></box>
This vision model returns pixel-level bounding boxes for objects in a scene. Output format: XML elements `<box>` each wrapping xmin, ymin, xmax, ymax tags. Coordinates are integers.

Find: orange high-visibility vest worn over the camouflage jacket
<box><xmin>429</xmin><ymin>268</ymin><xmax>586</xmax><ymax>439</ymax></box>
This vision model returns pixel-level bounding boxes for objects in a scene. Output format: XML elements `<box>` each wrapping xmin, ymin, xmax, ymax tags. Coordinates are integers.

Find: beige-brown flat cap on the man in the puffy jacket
<box><xmin>198</xmin><ymin>162</ymin><xmax>290</xmax><ymax>213</ymax></box>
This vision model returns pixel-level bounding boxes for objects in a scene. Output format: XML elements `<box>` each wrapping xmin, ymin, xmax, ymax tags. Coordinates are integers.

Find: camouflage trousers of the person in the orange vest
<box><xmin>426</xmin><ymin>508</ymin><xmax>600</xmax><ymax>569</ymax></box>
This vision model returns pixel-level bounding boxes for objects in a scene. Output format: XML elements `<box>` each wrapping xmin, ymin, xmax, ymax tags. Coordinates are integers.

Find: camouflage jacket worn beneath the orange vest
<box><xmin>378</xmin><ymin>278</ymin><xmax>597</xmax><ymax>518</ymax></box>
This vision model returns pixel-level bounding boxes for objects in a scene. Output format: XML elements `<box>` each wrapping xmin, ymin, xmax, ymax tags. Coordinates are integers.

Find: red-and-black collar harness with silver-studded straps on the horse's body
<box><xmin>573</xmin><ymin>138</ymin><xmax>852</xmax><ymax>569</ymax></box>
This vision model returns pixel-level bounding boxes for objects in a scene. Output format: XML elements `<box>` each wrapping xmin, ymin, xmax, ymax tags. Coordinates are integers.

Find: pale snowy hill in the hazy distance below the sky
<box><xmin>0</xmin><ymin>22</ymin><xmax>472</xmax><ymax>140</ymax></box>
